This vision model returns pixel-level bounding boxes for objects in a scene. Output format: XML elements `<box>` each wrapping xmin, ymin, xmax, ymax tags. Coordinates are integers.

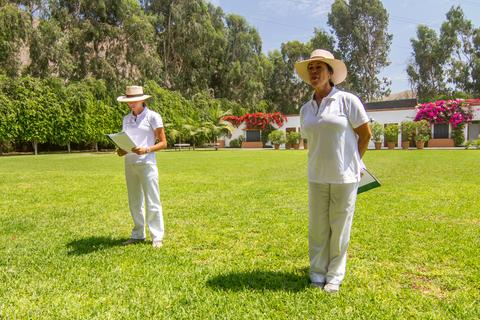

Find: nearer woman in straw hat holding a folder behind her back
<box><xmin>295</xmin><ymin>49</ymin><xmax>371</xmax><ymax>292</ymax></box>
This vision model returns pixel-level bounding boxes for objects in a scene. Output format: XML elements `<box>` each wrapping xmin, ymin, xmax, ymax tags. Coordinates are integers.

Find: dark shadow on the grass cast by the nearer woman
<box><xmin>207</xmin><ymin>268</ymin><xmax>310</xmax><ymax>292</ymax></box>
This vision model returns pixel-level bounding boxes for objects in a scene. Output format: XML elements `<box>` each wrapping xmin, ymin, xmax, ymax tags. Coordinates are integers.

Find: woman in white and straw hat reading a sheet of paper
<box><xmin>117</xmin><ymin>86</ymin><xmax>167</xmax><ymax>248</ymax></box>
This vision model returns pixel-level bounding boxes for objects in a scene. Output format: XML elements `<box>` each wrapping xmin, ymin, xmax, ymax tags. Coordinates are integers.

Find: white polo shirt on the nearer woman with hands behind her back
<box><xmin>300</xmin><ymin>87</ymin><xmax>368</xmax><ymax>183</ymax></box>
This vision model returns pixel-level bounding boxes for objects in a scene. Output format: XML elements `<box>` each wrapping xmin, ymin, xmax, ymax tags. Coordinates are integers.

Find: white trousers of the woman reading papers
<box><xmin>125</xmin><ymin>164</ymin><xmax>164</xmax><ymax>241</ymax></box>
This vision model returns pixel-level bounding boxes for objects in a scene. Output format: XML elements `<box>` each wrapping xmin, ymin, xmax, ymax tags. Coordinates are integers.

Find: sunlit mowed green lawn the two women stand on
<box><xmin>0</xmin><ymin>150</ymin><xmax>480</xmax><ymax>319</ymax></box>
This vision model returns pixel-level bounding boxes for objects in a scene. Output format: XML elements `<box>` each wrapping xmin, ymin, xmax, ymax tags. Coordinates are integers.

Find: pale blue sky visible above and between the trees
<box><xmin>209</xmin><ymin>0</ymin><xmax>480</xmax><ymax>93</ymax></box>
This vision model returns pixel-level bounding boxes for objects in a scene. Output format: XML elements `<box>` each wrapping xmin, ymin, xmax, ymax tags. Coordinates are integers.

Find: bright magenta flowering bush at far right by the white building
<box><xmin>415</xmin><ymin>99</ymin><xmax>473</xmax><ymax>146</ymax></box>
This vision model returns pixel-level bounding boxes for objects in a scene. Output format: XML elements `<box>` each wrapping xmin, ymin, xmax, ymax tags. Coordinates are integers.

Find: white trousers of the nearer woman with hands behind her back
<box><xmin>308</xmin><ymin>182</ymin><xmax>358</xmax><ymax>285</ymax></box>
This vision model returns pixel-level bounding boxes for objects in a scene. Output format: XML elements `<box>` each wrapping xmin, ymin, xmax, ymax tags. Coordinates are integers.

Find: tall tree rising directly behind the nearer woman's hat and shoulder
<box><xmin>328</xmin><ymin>0</ymin><xmax>392</xmax><ymax>101</ymax></box>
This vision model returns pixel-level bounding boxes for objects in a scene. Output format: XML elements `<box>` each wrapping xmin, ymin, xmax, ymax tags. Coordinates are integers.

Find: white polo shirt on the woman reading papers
<box><xmin>122</xmin><ymin>107</ymin><xmax>163</xmax><ymax>164</ymax></box>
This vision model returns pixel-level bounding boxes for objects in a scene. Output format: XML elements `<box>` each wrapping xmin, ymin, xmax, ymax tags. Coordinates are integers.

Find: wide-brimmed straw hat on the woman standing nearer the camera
<box><xmin>295</xmin><ymin>49</ymin><xmax>347</xmax><ymax>84</ymax></box>
